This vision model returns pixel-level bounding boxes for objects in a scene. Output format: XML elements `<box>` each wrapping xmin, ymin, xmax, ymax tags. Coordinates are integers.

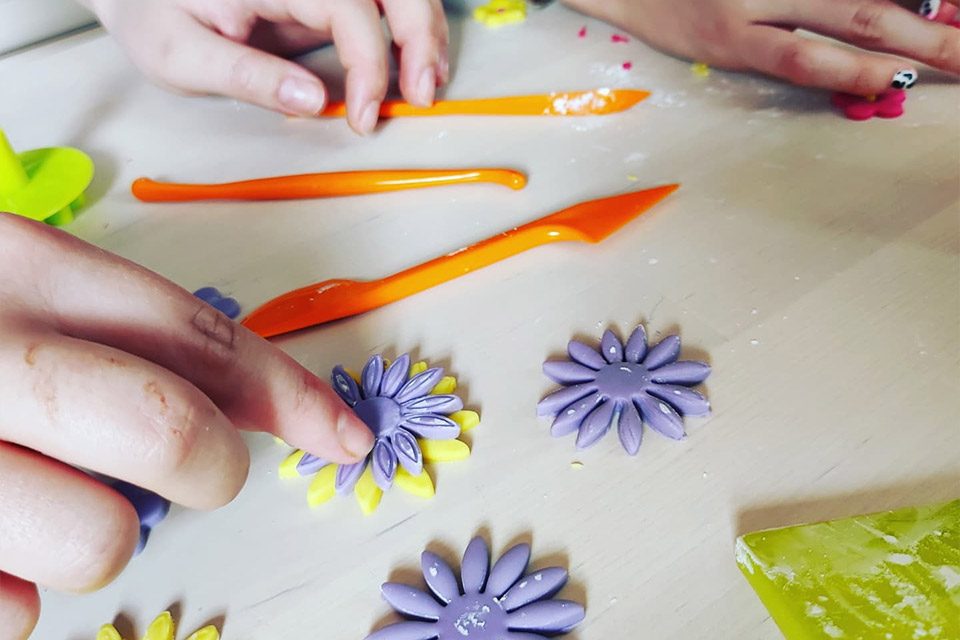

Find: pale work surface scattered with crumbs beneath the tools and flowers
<box><xmin>0</xmin><ymin>6</ymin><xmax>960</xmax><ymax>640</ymax></box>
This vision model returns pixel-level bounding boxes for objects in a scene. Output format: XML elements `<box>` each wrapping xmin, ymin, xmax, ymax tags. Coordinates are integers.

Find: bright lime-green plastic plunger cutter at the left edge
<box><xmin>0</xmin><ymin>129</ymin><xmax>93</xmax><ymax>226</ymax></box>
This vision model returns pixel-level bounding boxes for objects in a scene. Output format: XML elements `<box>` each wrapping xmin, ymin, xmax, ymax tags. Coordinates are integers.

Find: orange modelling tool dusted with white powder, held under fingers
<box><xmin>320</xmin><ymin>89</ymin><xmax>650</xmax><ymax>118</ymax></box>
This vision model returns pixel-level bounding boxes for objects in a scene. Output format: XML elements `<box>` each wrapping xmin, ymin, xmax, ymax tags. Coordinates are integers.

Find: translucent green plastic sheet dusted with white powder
<box><xmin>736</xmin><ymin>500</ymin><xmax>960</xmax><ymax>640</ymax></box>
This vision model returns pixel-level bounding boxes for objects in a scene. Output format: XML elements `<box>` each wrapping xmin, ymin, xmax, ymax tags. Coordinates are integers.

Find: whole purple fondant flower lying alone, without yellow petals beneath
<box><xmin>537</xmin><ymin>326</ymin><xmax>710</xmax><ymax>455</ymax></box>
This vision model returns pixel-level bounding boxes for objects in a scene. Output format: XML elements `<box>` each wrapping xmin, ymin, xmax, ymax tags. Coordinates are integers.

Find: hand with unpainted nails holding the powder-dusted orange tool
<box><xmin>81</xmin><ymin>0</ymin><xmax>449</xmax><ymax>134</ymax></box>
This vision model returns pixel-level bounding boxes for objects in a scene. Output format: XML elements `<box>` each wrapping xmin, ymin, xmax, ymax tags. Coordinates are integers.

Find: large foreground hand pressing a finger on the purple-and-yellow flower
<box><xmin>0</xmin><ymin>214</ymin><xmax>373</xmax><ymax>640</ymax></box>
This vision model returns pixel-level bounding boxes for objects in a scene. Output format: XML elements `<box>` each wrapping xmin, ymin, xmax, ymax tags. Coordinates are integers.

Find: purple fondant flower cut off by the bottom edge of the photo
<box><xmin>366</xmin><ymin>537</ymin><xmax>584</xmax><ymax>640</ymax></box>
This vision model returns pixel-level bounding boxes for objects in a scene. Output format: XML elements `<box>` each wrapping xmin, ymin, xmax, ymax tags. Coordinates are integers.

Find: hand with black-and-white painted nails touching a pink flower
<box><xmin>564</xmin><ymin>0</ymin><xmax>960</xmax><ymax>95</ymax></box>
